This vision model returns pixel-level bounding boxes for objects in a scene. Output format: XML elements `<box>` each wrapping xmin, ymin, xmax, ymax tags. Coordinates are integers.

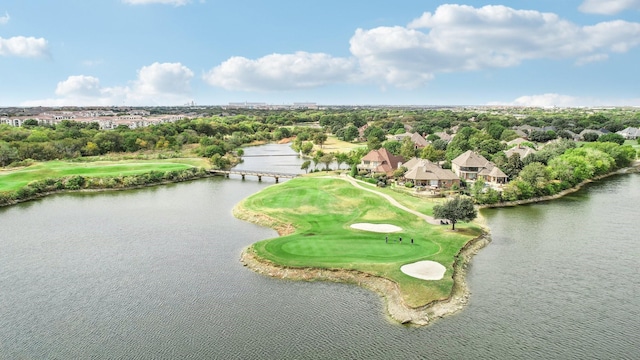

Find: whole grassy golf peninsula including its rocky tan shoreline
<box><xmin>234</xmin><ymin>177</ymin><xmax>483</xmax><ymax>325</ymax></box>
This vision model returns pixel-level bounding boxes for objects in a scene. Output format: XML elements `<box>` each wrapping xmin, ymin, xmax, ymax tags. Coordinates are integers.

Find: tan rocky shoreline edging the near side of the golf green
<box><xmin>240</xmin><ymin>233</ymin><xmax>490</xmax><ymax>326</ymax></box>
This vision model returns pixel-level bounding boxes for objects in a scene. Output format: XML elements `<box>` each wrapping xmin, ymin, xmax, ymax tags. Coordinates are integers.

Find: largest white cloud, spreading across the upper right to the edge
<box><xmin>351</xmin><ymin>4</ymin><xmax>640</xmax><ymax>86</ymax></box>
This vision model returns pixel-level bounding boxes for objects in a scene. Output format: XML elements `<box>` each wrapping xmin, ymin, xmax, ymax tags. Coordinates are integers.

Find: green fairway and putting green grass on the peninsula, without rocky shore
<box><xmin>236</xmin><ymin>177</ymin><xmax>481</xmax><ymax>306</ymax></box>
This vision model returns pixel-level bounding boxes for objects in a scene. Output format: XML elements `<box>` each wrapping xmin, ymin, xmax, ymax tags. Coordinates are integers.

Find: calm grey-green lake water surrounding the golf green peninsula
<box><xmin>0</xmin><ymin>148</ymin><xmax>640</xmax><ymax>359</ymax></box>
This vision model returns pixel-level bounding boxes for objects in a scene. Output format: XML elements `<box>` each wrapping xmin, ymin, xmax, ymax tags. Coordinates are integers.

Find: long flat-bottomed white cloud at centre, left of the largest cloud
<box><xmin>203</xmin><ymin>52</ymin><xmax>356</xmax><ymax>91</ymax></box>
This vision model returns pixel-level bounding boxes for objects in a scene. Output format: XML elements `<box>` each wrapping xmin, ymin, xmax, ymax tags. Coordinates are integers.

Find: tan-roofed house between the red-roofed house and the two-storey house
<box><xmin>402</xmin><ymin>158</ymin><xmax>460</xmax><ymax>188</ymax></box>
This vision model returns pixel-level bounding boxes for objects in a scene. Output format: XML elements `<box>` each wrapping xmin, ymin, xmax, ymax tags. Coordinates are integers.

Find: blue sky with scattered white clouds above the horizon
<box><xmin>0</xmin><ymin>0</ymin><xmax>640</xmax><ymax>106</ymax></box>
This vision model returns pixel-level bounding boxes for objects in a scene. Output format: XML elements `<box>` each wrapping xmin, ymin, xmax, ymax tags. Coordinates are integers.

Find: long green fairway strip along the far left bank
<box><xmin>0</xmin><ymin>159</ymin><xmax>199</xmax><ymax>191</ymax></box>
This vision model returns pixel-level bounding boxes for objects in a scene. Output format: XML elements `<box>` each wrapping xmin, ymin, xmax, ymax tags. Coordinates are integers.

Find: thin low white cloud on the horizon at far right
<box><xmin>487</xmin><ymin>93</ymin><xmax>640</xmax><ymax>107</ymax></box>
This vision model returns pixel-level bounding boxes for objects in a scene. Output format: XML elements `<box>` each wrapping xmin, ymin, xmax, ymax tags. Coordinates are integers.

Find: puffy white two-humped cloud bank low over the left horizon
<box><xmin>21</xmin><ymin>62</ymin><xmax>193</xmax><ymax>106</ymax></box>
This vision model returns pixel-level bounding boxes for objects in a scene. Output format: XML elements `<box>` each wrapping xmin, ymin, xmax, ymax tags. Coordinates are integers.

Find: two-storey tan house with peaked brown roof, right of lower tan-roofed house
<box><xmin>451</xmin><ymin>150</ymin><xmax>507</xmax><ymax>184</ymax></box>
